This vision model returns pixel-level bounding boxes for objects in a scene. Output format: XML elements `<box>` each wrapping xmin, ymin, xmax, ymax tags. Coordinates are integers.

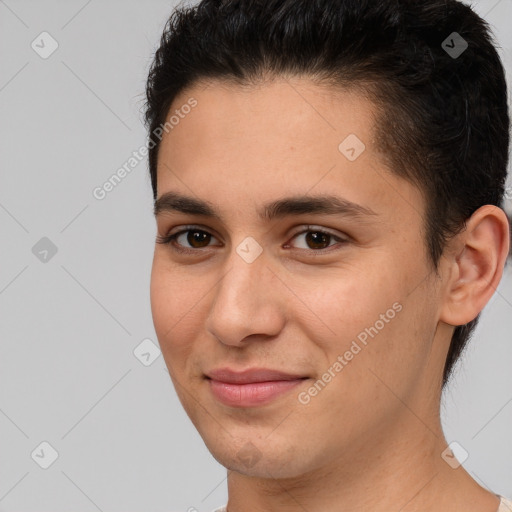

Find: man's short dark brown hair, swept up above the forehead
<box><xmin>145</xmin><ymin>0</ymin><xmax>510</xmax><ymax>385</ymax></box>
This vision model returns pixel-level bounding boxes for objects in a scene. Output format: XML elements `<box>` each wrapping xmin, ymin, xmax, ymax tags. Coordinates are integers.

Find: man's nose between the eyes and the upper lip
<box><xmin>206</xmin><ymin>241</ymin><xmax>284</xmax><ymax>346</ymax></box>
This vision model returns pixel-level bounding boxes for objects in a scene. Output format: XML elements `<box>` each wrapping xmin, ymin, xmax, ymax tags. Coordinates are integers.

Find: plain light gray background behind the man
<box><xmin>0</xmin><ymin>0</ymin><xmax>512</xmax><ymax>512</ymax></box>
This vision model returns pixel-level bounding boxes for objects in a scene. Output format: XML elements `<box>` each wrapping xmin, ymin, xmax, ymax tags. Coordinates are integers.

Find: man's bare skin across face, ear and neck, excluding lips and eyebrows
<box><xmin>151</xmin><ymin>77</ymin><xmax>509</xmax><ymax>512</ymax></box>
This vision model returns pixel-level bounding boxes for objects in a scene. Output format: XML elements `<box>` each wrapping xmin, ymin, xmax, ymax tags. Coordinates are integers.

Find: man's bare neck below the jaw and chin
<box><xmin>224</xmin><ymin>407</ymin><xmax>499</xmax><ymax>512</ymax></box>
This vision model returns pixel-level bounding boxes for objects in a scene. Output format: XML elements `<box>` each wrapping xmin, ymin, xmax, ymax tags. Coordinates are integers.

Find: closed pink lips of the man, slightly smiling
<box><xmin>206</xmin><ymin>368</ymin><xmax>309</xmax><ymax>407</ymax></box>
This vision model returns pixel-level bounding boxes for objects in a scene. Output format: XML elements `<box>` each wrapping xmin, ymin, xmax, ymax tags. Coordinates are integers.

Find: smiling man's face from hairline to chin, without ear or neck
<box><xmin>151</xmin><ymin>79</ymin><xmax>447</xmax><ymax>477</ymax></box>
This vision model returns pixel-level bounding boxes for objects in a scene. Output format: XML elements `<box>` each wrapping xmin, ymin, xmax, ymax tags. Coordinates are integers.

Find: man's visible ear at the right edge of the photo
<box><xmin>440</xmin><ymin>205</ymin><xmax>510</xmax><ymax>326</ymax></box>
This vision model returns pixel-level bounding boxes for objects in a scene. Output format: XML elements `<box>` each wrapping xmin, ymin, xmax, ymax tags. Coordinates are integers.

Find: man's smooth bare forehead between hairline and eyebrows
<box><xmin>157</xmin><ymin>78</ymin><xmax>421</xmax><ymax>226</ymax></box>
